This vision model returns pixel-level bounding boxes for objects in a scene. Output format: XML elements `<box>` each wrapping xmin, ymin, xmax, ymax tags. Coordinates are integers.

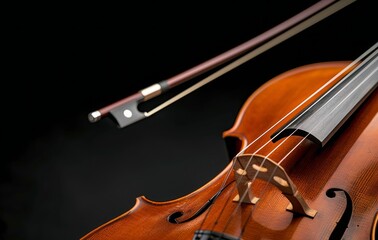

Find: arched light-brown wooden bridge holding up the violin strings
<box><xmin>233</xmin><ymin>154</ymin><xmax>317</xmax><ymax>218</ymax></box>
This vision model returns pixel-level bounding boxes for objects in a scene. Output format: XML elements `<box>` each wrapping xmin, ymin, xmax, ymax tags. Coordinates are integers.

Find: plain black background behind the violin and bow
<box><xmin>0</xmin><ymin>0</ymin><xmax>377</xmax><ymax>239</ymax></box>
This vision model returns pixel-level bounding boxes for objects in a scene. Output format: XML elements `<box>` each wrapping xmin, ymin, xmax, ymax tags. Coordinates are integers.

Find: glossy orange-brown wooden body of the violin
<box><xmin>81</xmin><ymin>62</ymin><xmax>378</xmax><ymax>240</ymax></box>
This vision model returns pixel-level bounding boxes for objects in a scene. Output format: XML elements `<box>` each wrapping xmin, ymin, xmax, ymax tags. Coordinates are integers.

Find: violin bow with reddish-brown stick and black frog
<box><xmin>88</xmin><ymin>0</ymin><xmax>356</xmax><ymax>128</ymax></box>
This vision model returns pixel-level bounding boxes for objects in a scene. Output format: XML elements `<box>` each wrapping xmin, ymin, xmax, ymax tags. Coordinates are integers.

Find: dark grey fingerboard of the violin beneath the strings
<box><xmin>272</xmin><ymin>44</ymin><xmax>378</xmax><ymax>146</ymax></box>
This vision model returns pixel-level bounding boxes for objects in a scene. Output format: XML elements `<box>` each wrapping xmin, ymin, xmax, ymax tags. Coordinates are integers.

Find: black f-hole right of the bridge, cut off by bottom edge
<box><xmin>326</xmin><ymin>188</ymin><xmax>353</xmax><ymax>240</ymax></box>
